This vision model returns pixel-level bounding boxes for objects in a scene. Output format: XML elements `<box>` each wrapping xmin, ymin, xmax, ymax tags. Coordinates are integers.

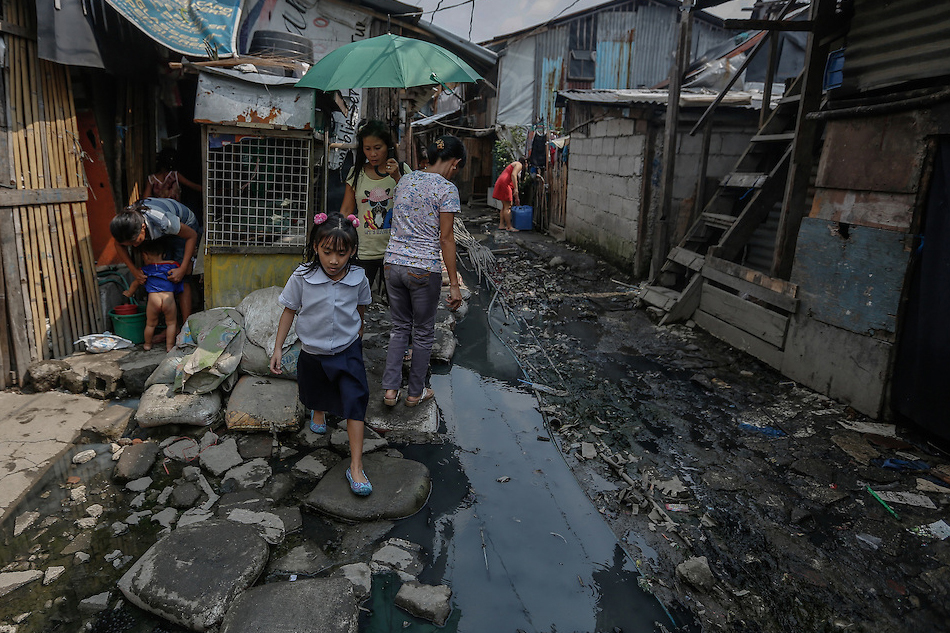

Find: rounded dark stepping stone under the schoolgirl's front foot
<box><xmin>304</xmin><ymin>453</ymin><xmax>432</xmax><ymax>521</ymax></box>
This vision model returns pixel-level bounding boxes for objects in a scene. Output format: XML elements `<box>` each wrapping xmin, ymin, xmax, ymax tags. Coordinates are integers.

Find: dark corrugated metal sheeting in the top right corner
<box><xmin>844</xmin><ymin>0</ymin><xmax>950</xmax><ymax>90</ymax></box>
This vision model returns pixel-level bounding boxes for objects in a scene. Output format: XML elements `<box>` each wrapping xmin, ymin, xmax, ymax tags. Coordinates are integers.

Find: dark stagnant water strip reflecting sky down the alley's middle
<box><xmin>361</xmin><ymin>278</ymin><xmax>692</xmax><ymax>633</ymax></box>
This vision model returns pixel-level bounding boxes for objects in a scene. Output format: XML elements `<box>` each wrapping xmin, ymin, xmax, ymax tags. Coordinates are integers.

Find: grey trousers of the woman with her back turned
<box><xmin>383</xmin><ymin>264</ymin><xmax>442</xmax><ymax>398</ymax></box>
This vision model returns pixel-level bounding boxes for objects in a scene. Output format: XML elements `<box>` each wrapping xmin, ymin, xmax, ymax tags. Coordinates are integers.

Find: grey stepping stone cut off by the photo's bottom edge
<box><xmin>221</xmin><ymin>578</ymin><xmax>359</xmax><ymax>633</ymax></box>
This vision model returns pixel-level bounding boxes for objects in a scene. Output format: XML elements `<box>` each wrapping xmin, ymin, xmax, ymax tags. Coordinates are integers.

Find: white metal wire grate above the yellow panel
<box><xmin>205</xmin><ymin>132</ymin><xmax>311</xmax><ymax>247</ymax></box>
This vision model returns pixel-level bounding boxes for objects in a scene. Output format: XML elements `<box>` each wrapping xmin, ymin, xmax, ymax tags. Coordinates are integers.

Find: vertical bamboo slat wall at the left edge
<box><xmin>0</xmin><ymin>0</ymin><xmax>104</xmax><ymax>387</ymax></box>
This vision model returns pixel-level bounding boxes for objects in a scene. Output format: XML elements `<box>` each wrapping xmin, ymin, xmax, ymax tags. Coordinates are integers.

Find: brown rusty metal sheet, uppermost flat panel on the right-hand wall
<box><xmin>816</xmin><ymin>112</ymin><xmax>928</xmax><ymax>193</ymax></box>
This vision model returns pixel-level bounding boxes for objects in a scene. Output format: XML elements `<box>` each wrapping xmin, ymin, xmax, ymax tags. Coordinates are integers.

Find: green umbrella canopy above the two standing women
<box><xmin>296</xmin><ymin>33</ymin><xmax>481</xmax><ymax>92</ymax></box>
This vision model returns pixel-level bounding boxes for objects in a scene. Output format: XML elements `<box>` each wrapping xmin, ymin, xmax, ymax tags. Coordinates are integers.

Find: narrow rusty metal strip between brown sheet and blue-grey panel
<box><xmin>809</xmin><ymin>189</ymin><xmax>916</xmax><ymax>232</ymax></box>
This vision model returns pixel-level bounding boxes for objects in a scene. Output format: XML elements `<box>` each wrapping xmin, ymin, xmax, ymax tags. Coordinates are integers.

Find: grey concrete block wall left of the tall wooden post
<box><xmin>564</xmin><ymin>118</ymin><xmax>646</xmax><ymax>269</ymax></box>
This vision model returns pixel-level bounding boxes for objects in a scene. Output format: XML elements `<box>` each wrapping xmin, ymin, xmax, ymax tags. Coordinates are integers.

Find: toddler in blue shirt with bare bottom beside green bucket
<box><xmin>122</xmin><ymin>239</ymin><xmax>182</xmax><ymax>351</ymax></box>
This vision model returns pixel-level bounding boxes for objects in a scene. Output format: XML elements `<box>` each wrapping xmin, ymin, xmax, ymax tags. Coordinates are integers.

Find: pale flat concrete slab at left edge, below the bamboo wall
<box><xmin>0</xmin><ymin>391</ymin><xmax>106</xmax><ymax>522</ymax></box>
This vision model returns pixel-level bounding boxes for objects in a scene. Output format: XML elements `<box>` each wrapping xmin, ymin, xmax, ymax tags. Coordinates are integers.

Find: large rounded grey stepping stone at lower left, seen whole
<box><xmin>118</xmin><ymin>519</ymin><xmax>270</xmax><ymax>631</ymax></box>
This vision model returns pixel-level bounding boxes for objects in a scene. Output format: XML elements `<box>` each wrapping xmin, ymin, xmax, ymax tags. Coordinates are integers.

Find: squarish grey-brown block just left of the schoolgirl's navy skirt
<box><xmin>224</xmin><ymin>376</ymin><xmax>304</xmax><ymax>431</ymax></box>
